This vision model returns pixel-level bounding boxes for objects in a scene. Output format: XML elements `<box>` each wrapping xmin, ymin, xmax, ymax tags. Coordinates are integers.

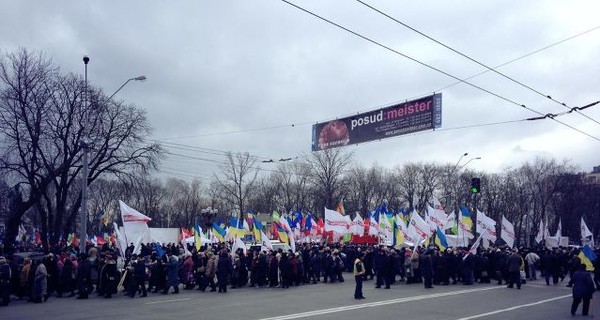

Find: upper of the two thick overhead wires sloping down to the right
<box><xmin>356</xmin><ymin>0</ymin><xmax>600</xmax><ymax>124</ymax></box>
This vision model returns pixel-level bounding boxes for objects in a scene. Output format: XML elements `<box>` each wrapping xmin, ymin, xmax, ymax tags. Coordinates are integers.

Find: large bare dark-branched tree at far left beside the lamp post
<box><xmin>0</xmin><ymin>49</ymin><xmax>161</xmax><ymax>252</ymax></box>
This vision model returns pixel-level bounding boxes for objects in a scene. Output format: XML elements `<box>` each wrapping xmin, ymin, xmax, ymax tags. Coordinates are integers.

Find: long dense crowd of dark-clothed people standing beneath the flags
<box><xmin>0</xmin><ymin>243</ymin><xmax>600</xmax><ymax>309</ymax></box>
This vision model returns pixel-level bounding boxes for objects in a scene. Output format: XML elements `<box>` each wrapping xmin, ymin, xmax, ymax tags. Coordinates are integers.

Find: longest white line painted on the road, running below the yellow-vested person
<box><xmin>253</xmin><ymin>287</ymin><xmax>504</xmax><ymax>320</ymax></box>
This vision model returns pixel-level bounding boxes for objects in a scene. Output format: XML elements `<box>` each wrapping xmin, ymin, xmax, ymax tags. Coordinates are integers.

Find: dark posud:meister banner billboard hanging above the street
<box><xmin>312</xmin><ymin>93</ymin><xmax>442</xmax><ymax>151</ymax></box>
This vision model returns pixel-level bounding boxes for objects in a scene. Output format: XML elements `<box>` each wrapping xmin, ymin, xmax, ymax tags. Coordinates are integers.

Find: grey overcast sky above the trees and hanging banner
<box><xmin>0</xmin><ymin>0</ymin><xmax>600</xmax><ymax>179</ymax></box>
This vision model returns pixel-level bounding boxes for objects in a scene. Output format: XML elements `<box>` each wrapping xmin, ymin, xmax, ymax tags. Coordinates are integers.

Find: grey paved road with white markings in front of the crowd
<box><xmin>0</xmin><ymin>275</ymin><xmax>600</xmax><ymax>320</ymax></box>
